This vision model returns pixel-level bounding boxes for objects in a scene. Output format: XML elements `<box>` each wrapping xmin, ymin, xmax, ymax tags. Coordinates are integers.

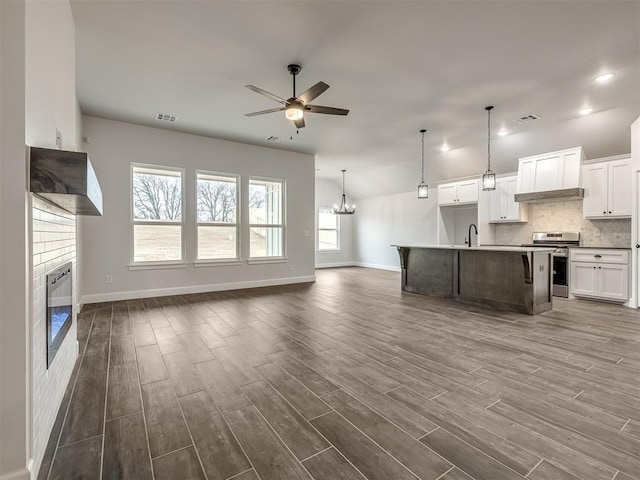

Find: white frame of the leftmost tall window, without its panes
<box><xmin>129</xmin><ymin>162</ymin><xmax>187</xmax><ymax>270</ymax></box>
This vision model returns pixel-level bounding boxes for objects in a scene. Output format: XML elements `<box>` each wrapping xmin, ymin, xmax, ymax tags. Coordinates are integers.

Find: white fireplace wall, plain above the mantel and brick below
<box><xmin>25</xmin><ymin>0</ymin><xmax>79</xmax><ymax>478</ymax></box>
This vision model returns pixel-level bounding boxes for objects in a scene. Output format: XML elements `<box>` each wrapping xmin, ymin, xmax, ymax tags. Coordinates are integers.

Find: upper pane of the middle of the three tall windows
<box><xmin>197</xmin><ymin>174</ymin><xmax>237</xmax><ymax>223</ymax></box>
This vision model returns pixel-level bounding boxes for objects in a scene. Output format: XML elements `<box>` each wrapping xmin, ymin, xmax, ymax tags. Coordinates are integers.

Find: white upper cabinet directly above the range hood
<box><xmin>516</xmin><ymin>147</ymin><xmax>583</xmax><ymax>193</ymax></box>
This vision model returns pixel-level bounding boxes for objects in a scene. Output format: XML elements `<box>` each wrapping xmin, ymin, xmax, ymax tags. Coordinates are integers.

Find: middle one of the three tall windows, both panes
<box><xmin>196</xmin><ymin>172</ymin><xmax>239</xmax><ymax>260</ymax></box>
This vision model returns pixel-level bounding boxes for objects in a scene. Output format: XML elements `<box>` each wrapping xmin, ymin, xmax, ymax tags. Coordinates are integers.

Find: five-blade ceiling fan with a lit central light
<box><xmin>245</xmin><ymin>64</ymin><xmax>349</xmax><ymax>128</ymax></box>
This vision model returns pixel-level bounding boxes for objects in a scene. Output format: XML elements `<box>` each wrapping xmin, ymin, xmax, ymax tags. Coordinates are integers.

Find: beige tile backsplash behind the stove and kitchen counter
<box><xmin>495</xmin><ymin>200</ymin><xmax>631</xmax><ymax>248</ymax></box>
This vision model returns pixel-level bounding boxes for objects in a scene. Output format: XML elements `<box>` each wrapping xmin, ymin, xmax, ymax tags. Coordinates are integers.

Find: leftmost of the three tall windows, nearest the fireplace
<box><xmin>131</xmin><ymin>165</ymin><xmax>184</xmax><ymax>263</ymax></box>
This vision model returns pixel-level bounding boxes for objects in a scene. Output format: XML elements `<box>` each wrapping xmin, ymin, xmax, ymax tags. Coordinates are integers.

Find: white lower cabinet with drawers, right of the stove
<box><xmin>570</xmin><ymin>249</ymin><xmax>629</xmax><ymax>302</ymax></box>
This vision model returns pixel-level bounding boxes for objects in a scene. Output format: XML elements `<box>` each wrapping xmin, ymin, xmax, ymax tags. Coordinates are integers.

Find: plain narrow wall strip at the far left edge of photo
<box><xmin>0</xmin><ymin>0</ymin><xmax>30</xmax><ymax>480</ymax></box>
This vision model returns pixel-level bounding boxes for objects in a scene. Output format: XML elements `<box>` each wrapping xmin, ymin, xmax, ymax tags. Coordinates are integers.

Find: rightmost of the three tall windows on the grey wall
<box><xmin>249</xmin><ymin>178</ymin><xmax>285</xmax><ymax>258</ymax></box>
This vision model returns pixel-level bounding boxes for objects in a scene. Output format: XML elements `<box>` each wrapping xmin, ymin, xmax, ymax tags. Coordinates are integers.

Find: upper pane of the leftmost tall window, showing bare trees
<box><xmin>133</xmin><ymin>167</ymin><xmax>182</xmax><ymax>222</ymax></box>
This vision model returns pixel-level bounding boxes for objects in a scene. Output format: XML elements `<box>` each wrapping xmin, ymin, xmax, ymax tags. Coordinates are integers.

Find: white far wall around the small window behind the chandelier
<box><xmin>314</xmin><ymin>178</ymin><xmax>359</xmax><ymax>268</ymax></box>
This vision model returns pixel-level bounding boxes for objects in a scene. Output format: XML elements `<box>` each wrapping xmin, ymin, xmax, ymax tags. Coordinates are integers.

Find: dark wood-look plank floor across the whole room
<box><xmin>39</xmin><ymin>268</ymin><xmax>640</xmax><ymax>480</ymax></box>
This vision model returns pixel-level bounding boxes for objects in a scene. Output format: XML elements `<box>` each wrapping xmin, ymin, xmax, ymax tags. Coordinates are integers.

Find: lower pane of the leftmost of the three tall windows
<box><xmin>133</xmin><ymin>225</ymin><xmax>182</xmax><ymax>262</ymax></box>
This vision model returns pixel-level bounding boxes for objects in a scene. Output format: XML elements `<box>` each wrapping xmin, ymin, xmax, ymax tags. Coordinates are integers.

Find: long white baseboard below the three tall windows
<box><xmin>81</xmin><ymin>275</ymin><xmax>316</xmax><ymax>304</ymax></box>
